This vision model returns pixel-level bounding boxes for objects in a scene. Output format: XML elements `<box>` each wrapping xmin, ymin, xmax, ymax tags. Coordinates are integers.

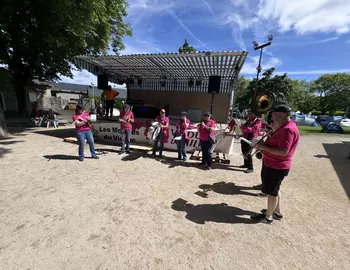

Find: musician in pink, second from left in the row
<box><xmin>119</xmin><ymin>104</ymin><xmax>135</xmax><ymax>154</ymax></box>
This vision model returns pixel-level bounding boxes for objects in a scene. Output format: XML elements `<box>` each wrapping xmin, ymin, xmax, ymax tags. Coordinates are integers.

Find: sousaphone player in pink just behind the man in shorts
<box><xmin>240</xmin><ymin>111</ymin><xmax>261</xmax><ymax>173</ymax></box>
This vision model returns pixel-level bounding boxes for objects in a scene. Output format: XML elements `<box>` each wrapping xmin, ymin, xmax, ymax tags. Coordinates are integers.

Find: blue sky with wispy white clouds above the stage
<box><xmin>62</xmin><ymin>0</ymin><xmax>350</xmax><ymax>84</ymax></box>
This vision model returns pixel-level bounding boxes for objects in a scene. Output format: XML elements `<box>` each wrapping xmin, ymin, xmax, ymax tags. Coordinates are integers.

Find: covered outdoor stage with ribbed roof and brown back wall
<box><xmin>74</xmin><ymin>51</ymin><xmax>248</xmax><ymax>123</ymax></box>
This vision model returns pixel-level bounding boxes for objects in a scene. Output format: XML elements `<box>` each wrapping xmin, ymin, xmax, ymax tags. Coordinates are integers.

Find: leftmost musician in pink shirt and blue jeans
<box><xmin>73</xmin><ymin>104</ymin><xmax>98</xmax><ymax>161</ymax></box>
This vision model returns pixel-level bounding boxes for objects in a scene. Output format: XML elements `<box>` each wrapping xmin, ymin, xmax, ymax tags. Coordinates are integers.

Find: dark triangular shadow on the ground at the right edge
<box><xmin>323</xmin><ymin>141</ymin><xmax>350</xmax><ymax>199</ymax></box>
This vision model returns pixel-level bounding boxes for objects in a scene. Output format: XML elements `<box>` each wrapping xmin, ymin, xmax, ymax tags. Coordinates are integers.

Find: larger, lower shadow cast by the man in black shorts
<box><xmin>171</xmin><ymin>198</ymin><xmax>257</xmax><ymax>224</ymax></box>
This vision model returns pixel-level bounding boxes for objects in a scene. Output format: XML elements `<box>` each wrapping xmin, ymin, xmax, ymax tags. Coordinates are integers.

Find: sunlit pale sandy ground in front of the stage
<box><xmin>0</xmin><ymin>129</ymin><xmax>350</xmax><ymax>270</ymax></box>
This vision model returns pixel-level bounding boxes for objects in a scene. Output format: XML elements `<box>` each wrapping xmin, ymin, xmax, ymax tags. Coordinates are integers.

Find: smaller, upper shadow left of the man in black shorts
<box><xmin>195</xmin><ymin>182</ymin><xmax>258</xmax><ymax>198</ymax></box>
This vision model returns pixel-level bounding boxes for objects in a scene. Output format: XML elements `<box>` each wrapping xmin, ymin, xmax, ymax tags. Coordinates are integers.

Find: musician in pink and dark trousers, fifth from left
<box><xmin>198</xmin><ymin>113</ymin><xmax>216</xmax><ymax>170</ymax></box>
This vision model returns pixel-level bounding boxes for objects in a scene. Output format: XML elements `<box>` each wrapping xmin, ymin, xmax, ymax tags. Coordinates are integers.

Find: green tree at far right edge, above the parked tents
<box><xmin>311</xmin><ymin>73</ymin><xmax>350</xmax><ymax>114</ymax></box>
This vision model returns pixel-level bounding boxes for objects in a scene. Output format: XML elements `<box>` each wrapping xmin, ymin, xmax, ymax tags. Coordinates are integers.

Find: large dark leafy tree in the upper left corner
<box><xmin>0</xmin><ymin>0</ymin><xmax>132</xmax><ymax>113</ymax></box>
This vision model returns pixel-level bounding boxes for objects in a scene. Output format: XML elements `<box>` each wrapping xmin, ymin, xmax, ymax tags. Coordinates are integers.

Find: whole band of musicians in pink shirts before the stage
<box><xmin>73</xmin><ymin>105</ymin><xmax>300</xmax><ymax>224</ymax></box>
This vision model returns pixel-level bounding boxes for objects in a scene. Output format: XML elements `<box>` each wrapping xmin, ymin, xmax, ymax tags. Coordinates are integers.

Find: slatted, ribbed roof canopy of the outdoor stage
<box><xmin>74</xmin><ymin>51</ymin><xmax>248</xmax><ymax>83</ymax></box>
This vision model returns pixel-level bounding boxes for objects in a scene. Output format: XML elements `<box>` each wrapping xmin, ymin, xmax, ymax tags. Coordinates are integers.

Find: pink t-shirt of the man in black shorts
<box><xmin>263</xmin><ymin>121</ymin><xmax>300</xmax><ymax>170</ymax></box>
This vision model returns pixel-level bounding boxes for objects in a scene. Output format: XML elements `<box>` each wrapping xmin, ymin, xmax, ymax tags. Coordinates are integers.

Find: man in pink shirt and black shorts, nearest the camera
<box><xmin>251</xmin><ymin>105</ymin><xmax>300</xmax><ymax>224</ymax></box>
